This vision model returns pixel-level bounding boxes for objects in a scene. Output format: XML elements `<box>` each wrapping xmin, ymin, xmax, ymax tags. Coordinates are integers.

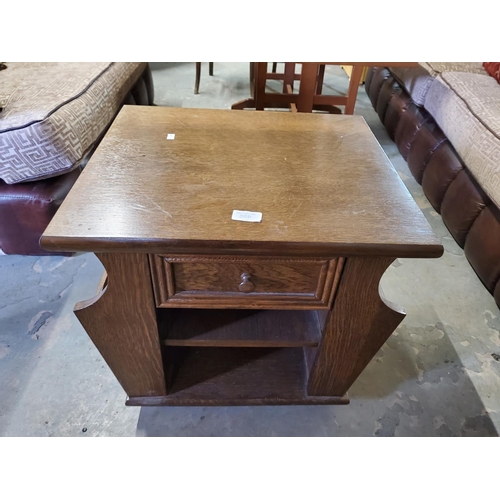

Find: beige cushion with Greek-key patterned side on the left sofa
<box><xmin>0</xmin><ymin>62</ymin><xmax>146</xmax><ymax>184</ymax></box>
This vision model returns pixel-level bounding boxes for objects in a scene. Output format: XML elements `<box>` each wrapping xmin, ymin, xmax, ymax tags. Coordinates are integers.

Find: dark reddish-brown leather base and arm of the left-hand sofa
<box><xmin>0</xmin><ymin>63</ymin><xmax>154</xmax><ymax>255</ymax></box>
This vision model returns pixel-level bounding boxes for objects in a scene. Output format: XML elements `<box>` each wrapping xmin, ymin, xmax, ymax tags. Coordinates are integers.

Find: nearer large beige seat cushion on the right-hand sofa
<box><xmin>425</xmin><ymin>72</ymin><xmax>500</xmax><ymax>207</ymax></box>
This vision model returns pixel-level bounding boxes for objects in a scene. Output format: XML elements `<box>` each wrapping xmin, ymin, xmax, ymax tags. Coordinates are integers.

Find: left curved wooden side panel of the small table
<box><xmin>75</xmin><ymin>253</ymin><xmax>166</xmax><ymax>397</ymax></box>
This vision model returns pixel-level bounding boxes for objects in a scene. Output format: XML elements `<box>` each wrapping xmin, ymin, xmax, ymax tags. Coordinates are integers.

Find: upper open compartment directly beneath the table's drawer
<box><xmin>157</xmin><ymin>309</ymin><xmax>321</xmax><ymax>347</ymax></box>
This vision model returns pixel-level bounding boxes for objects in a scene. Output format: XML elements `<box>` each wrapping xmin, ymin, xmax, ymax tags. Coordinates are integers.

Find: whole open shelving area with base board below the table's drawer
<box><xmin>122</xmin><ymin>309</ymin><xmax>349</xmax><ymax>406</ymax></box>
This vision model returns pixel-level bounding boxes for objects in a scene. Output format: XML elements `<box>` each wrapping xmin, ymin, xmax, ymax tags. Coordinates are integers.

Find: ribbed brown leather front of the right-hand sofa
<box><xmin>365</xmin><ymin>67</ymin><xmax>500</xmax><ymax>306</ymax></box>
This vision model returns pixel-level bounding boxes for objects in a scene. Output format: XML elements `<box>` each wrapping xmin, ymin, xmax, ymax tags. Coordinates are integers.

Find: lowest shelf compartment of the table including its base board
<box><xmin>127</xmin><ymin>347</ymin><xmax>349</xmax><ymax>406</ymax></box>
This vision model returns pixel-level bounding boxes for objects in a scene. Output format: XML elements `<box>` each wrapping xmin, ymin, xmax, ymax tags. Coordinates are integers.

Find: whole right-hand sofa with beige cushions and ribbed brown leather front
<box><xmin>366</xmin><ymin>63</ymin><xmax>500</xmax><ymax>305</ymax></box>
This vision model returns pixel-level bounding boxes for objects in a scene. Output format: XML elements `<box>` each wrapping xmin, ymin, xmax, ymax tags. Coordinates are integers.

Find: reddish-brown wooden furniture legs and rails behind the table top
<box><xmin>231</xmin><ymin>62</ymin><xmax>417</xmax><ymax>115</ymax></box>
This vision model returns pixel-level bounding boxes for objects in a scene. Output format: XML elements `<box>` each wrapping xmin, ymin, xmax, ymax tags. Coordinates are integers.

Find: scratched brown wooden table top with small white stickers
<box><xmin>42</xmin><ymin>106</ymin><xmax>442</xmax><ymax>257</ymax></box>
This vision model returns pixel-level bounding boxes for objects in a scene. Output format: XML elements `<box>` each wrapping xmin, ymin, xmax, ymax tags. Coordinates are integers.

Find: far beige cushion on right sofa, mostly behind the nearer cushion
<box><xmin>389</xmin><ymin>62</ymin><xmax>486</xmax><ymax>106</ymax></box>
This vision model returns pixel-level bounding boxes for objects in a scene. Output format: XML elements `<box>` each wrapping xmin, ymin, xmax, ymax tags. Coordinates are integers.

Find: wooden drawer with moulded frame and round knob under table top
<box><xmin>150</xmin><ymin>255</ymin><xmax>342</xmax><ymax>309</ymax></box>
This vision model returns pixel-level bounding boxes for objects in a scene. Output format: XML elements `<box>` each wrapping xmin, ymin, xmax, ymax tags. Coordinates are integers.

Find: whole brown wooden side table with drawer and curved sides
<box><xmin>42</xmin><ymin>106</ymin><xmax>443</xmax><ymax>406</ymax></box>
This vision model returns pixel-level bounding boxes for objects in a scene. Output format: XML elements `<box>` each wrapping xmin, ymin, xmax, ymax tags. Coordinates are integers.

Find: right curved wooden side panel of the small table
<box><xmin>308</xmin><ymin>257</ymin><xmax>405</xmax><ymax>396</ymax></box>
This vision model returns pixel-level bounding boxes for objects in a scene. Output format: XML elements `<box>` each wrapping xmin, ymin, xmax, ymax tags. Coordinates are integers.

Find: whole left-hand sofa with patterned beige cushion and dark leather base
<box><xmin>0</xmin><ymin>63</ymin><xmax>154</xmax><ymax>255</ymax></box>
